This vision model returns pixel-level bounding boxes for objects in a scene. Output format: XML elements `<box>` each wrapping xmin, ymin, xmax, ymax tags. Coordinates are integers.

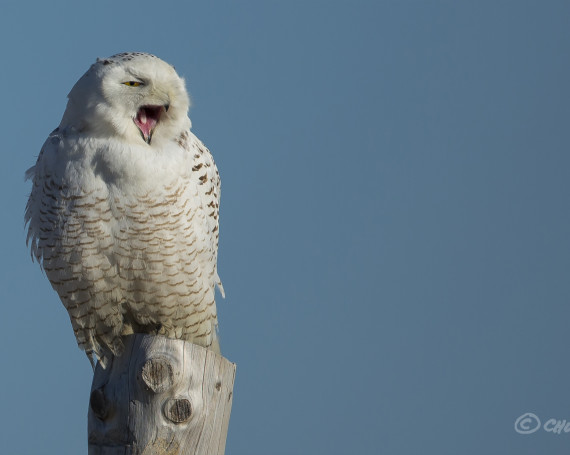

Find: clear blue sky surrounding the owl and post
<box><xmin>0</xmin><ymin>0</ymin><xmax>570</xmax><ymax>455</ymax></box>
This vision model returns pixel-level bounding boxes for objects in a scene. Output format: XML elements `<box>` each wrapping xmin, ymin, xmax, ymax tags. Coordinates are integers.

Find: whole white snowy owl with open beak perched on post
<box><xmin>25</xmin><ymin>52</ymin><xmax>223</xmax><ymax>367</ymax></box>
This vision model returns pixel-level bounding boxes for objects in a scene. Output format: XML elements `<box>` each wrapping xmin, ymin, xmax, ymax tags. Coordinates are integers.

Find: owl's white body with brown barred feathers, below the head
<box><xmin>26</xmin><ymin>129</ymin><xmax>223</xmax><ymax>366</ymax></box>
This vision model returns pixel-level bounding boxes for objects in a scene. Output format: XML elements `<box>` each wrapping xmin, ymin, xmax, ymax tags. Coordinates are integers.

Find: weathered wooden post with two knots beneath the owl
<box><xmin>88</xmin><ymin>334</ymin><xmax>236</xmax><ymax>455</ymax></box>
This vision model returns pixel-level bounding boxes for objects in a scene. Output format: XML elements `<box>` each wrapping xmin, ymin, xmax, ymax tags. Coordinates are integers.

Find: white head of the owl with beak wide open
<box><xmin>60</xmin><ymin>52</ymin><xmax>191</xmax><ymax>146</ymax></box>
